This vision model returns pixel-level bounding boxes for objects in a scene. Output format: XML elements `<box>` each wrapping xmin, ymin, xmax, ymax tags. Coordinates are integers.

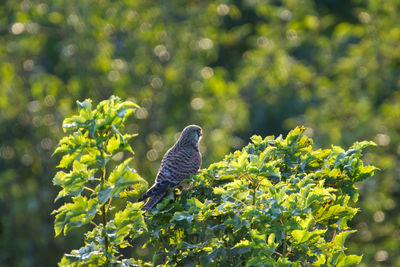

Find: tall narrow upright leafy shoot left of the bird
<box><xmin>53</xmin><ymin>96</ymin><xmax>147</xmax><ymax>266</ymax></box>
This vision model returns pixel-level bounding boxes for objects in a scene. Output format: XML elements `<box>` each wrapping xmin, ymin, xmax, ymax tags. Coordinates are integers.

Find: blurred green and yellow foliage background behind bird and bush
<box><xmin>0</xmin><ymin>0</ymin><xmax>400</xmax><ymax>266</ymax></box>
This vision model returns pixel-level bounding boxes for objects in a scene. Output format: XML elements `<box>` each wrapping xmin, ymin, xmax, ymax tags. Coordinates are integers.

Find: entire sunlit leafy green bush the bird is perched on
<box><xmin>54</xmin><ymin>97</ymin><xmax>375</xmax><ymax>266</ymax></box>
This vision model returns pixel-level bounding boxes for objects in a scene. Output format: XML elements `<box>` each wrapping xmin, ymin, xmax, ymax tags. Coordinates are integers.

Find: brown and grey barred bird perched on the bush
<box><xmin>137</xmin><ymin>125</ymin><xmax>202</xmax><ymax>211</ymax></box>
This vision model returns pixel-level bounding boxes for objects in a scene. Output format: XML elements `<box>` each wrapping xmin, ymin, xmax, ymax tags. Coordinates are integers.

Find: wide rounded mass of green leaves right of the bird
<box><xmin>146</xmin><ymin>127</ymin><xmax>375</xmax><ymax>266</ymax></box>
